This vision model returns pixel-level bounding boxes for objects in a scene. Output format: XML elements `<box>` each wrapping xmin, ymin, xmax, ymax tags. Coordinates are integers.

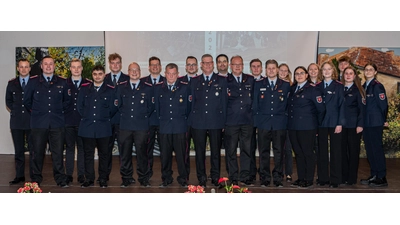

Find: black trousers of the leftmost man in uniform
<box><xmin>11</xmin><ymin>129</ymin><xmax>32</xmax><ymax>178</ymax></box>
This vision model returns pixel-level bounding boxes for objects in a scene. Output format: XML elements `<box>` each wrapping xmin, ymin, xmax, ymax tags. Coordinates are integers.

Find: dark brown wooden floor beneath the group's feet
<box><xmin>0</xmin><ymin>155</ymin><xmax>400</xmax><ymax>193</ymax></box>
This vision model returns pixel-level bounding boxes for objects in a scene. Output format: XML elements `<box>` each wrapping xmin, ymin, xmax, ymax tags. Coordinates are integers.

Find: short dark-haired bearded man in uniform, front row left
<box><xmin>77</xmin><ymin>65</ymin><xmax>118</xmax><ymax>188</ymax></box>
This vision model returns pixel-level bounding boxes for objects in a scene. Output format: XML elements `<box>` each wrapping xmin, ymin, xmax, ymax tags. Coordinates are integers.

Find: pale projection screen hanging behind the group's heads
<box><xmin>105</xmin><ymin>31</ymin><xmax>318</xmax><ymax>76</ymax></box>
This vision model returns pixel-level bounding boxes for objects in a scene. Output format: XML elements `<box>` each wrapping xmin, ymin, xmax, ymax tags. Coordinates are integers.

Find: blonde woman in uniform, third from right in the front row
<box><xmin>316</xmin><ymin>61</ymin><xmax>346</xmax><ymax>188</ymax></box>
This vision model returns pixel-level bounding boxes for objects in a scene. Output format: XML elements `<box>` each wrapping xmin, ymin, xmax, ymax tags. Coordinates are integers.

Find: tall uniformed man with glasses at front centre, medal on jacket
<box><xmin>190</xmin><ymin>54</ymin><xmax>228</xmax><ymax>187</ymax></box>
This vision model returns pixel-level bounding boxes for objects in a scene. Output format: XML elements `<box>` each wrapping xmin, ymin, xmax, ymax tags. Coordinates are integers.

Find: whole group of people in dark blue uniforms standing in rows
<box><xmin>6</xmin><ymin>53</ymin><xmax>388</xmax><ymax>188</ymax></box>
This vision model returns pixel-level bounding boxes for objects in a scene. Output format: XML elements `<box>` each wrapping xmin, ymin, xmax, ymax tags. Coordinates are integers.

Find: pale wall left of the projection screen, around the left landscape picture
<box><xmin>0</xmin><ymin>31</ymin><xmax>104</xmax><ymax>154</ymax></box>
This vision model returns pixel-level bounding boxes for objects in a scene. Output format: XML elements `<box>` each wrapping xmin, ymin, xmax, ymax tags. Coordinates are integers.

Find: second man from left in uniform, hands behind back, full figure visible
<box><xmin>24</xmin><ymin>56</ymin><xmax>71</xmax><ymax>188</ymax></box>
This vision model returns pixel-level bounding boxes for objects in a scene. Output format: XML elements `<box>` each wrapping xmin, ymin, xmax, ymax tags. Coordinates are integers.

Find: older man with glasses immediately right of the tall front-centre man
<box><xmin>224</xmin><ymin>55</ymin><xmax>254</xmax><ymax>185</ymax></box>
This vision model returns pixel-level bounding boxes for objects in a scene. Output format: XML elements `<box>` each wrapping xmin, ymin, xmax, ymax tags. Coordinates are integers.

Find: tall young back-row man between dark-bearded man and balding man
<box><xmin>104</xmin><ymin>53</ymin><xmax>129</xmax><ymax>180</ymax></box>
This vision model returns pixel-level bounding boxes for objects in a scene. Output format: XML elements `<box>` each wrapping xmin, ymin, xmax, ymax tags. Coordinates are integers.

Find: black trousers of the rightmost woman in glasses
<box><xmin>363</xmin><ymin>126</ymin><xmax>386</xmax><ymax>178</ymax></box>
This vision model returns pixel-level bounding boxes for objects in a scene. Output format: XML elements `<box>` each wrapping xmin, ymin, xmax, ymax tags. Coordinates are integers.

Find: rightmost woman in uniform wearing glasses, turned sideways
<box><xmin>361</xmin><ymin>63</ymin><xmax>388</xmax><ymax>187</ymax></box>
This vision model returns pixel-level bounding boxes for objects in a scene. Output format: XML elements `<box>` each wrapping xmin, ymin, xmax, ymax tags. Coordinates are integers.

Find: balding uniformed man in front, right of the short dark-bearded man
<box><xmin>117</xmin><ymin>62</ymin><xmax>154</xmax><ymax>187</ymax></box>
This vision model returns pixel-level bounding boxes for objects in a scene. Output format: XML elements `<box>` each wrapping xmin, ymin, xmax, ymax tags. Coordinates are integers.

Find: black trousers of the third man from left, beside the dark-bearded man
<box><xmin>65</xmin><ymin>126</ymin><xmax>85</xmax><ymax>176</ymax></box>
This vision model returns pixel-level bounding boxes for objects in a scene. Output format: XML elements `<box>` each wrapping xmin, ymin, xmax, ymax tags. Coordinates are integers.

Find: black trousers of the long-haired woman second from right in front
<box><xmin>342</xmin><ymin>128</ymin><xmax>361</xmax><ymax>184</ymax></box>
